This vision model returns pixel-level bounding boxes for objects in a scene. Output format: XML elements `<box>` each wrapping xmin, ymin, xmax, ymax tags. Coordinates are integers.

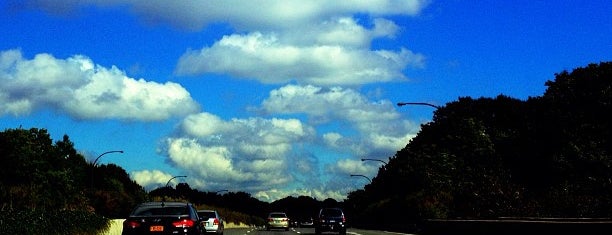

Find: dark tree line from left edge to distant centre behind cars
<box><xmin>0</xmin><ymin>128</ymin><xmax>337</xmax><ymax>225</ymax></box>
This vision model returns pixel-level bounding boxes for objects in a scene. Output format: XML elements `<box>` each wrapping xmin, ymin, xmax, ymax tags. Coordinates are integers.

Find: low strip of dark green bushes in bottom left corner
<box><xmin>0</xmin><ymin>210</ymin><xmax>110</xmax><ymax>235</ymax></box>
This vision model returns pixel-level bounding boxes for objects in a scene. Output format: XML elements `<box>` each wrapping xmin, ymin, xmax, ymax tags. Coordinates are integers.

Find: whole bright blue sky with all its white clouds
<box><xmin>0</xmin><ymin>0</ymin><xmax>612</xmax><ymax>201</ymax></box>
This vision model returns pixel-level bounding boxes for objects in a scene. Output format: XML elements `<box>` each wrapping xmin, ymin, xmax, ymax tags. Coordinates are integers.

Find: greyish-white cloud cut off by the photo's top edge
<box><xmin>19</xmin><ymin>0</ymin><xmax>429</xmax><ymax>31</ymax></box>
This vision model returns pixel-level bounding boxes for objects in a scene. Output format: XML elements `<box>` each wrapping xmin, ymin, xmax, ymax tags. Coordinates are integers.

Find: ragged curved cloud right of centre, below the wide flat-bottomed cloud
<box><xmin>260</xmin><ymin>85</ymin><xmax>419</xmax><ymax>153</ymax></box>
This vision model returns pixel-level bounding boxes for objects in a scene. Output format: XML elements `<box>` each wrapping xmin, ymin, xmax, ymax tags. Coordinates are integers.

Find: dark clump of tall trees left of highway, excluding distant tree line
<box><xmin>0</xmin><ymin>128</ymin><xmax>147</xmax><ymax>234</ymax></box>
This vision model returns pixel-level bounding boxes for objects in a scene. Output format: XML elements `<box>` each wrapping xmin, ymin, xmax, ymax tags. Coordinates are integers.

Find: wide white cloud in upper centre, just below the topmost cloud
<box><xmin>176</xmin><ymin>32</ymin><xmax>423</xmax><ymax>85</ymax></box>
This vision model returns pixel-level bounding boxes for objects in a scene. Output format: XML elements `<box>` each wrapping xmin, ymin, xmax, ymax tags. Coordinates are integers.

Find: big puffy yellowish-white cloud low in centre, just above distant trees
<box><xmin>158</xmin><ymin>113</ymin><xmax>315</xmax><ymax>194</ymax></box>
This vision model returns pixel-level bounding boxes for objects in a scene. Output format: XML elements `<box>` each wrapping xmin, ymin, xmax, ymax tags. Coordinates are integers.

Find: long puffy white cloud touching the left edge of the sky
<box><xmin>0</xmin><ymin>50</ymin><xmax>199</xmax><ymax>121</ymax></box>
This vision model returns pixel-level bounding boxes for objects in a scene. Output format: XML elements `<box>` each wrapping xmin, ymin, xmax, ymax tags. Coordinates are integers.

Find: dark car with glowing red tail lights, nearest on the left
<box><xmin>122</xmin><ymin>202</ymin><xmax>204</xmax><ymax>235</ymax></box>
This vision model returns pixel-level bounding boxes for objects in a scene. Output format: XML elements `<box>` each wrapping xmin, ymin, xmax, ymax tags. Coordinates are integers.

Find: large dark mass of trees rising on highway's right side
<box><xmin>346</xmin><ymin>62</ymin><xmax>612</xmax><ymax>231</ymax></box>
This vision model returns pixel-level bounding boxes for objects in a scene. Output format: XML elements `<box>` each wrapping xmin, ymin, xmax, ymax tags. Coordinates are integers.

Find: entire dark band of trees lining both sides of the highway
<box><xmin>0</xmin><ymin>62</ymin><xmax>612</xmax><ymax>234</ymax></box>
